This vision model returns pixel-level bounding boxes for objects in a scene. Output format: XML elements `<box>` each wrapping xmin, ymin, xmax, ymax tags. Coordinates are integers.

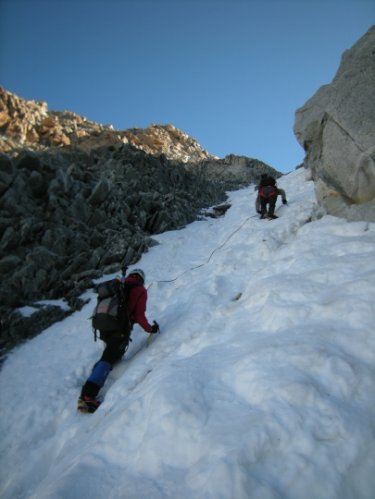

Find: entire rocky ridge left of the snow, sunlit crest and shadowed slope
<box><xmin>0</xmin><ymin>91</ymin><xmax>280</xmax><ymax>354</ymax></box>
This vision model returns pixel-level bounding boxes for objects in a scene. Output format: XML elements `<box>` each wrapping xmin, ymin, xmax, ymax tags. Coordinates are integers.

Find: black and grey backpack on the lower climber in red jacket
<box><xmin>91</xmin><ymin>279</ymin><xmax>134</xmax><ymax>341</ymax></box>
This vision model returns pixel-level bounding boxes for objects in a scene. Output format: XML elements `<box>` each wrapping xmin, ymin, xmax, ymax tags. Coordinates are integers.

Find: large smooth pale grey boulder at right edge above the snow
<box><xmin>294</xmin><ymin>26</ymin><xmax>375</xmax><ymax>221</ymax></box>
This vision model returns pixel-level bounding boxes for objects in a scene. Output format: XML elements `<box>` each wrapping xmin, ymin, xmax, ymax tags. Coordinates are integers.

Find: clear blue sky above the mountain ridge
<box><xmin>0</xmin><ymin>0</ymin><xmax>375</xmax><ymax>172</ymax></box>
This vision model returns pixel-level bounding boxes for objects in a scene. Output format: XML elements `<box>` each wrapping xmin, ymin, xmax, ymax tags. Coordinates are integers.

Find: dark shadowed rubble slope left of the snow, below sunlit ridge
<box><xmin>0</xmin><ymin>145</ymin><xmax>226</xmax><ymax>352</ymax></box>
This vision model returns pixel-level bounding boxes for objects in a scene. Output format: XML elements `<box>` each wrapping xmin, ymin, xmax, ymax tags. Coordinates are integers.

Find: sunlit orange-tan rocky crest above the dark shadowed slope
<box><xmin>0</xmin><ymin>87</ymin><xmax>215</xmax><ymax>163</ymax></box>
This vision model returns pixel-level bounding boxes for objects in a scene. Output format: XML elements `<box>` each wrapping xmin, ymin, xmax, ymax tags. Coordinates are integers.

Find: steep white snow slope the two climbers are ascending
<box><xmin>0</xmin><ymin>170</ymin><xmax>375</xmax><ymax>499</ymax></box>
